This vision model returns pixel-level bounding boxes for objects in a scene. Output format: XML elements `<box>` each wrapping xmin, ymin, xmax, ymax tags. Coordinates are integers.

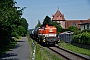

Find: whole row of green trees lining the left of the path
<box><xmin>0</xmin><ymin>0</ymin><xmax>28</xmax><ymax>49</ymax></box>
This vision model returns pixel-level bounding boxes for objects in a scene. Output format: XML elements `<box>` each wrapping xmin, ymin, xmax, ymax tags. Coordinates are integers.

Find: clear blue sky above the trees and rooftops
<box><xmin>14</xmin><ymin>0</ymin><xmax>90</xmax><ymax>29</ymax></box>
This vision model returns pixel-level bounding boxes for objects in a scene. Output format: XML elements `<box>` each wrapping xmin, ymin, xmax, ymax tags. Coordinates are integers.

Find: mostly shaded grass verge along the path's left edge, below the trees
<box><xmin>0</xmin><ymin>36</ymin><xmax>21</xmax><ymax>56</ymax></box>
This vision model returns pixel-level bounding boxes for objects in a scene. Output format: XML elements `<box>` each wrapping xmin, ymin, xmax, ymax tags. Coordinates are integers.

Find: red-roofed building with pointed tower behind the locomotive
<box><xmin>52</xmin><ymin>9</ymin><xmax>90</xmax><ymax>29</ymax></box>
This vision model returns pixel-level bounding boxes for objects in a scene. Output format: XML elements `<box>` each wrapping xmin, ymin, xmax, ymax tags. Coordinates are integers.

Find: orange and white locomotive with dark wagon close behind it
<box><xmin>30</xmin><ymin>25</ymin><xmax>60</xmax><ymax>44</ymax></box>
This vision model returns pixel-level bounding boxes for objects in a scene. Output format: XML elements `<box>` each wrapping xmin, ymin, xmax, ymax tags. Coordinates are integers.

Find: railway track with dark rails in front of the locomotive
<box><xmin>47</xmin><ymin>46</ymin><xmax>90</xmax><ymax>60</ymax></box>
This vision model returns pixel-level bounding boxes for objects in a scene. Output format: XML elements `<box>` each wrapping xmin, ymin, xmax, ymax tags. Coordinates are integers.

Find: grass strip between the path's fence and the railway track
<box><xmin>35</xmin><ymin>42</ymin><xmax>62</xmax><ymax>60</ymax></box>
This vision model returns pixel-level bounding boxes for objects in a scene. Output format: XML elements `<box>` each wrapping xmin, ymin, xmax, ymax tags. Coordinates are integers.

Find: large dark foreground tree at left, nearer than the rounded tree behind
<box><xmin>0</xmin><ymin>0</ymin><xmax>28</xmax><ymax>45</ymax></box>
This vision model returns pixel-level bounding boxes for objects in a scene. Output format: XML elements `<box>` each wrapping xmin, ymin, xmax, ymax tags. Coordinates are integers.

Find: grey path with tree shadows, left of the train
<box><xmin>0</xmin><ymin>37</ymin><xmax>30</xmax><ymax>60</ymax></box>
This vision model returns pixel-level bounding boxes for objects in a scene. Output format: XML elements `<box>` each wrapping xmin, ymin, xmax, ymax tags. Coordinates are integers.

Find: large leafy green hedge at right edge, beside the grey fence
<box><xmin>72</xmin><ymin>29</ymin><xmax>90</xmax><ymax>44</ymax></box>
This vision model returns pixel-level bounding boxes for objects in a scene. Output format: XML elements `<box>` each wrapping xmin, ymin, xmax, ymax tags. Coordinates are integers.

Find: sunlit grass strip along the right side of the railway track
<box><xmin>58</xmin><ymin>42</ymin><xmax>90</xmax><ymax>56</ymax></box>
